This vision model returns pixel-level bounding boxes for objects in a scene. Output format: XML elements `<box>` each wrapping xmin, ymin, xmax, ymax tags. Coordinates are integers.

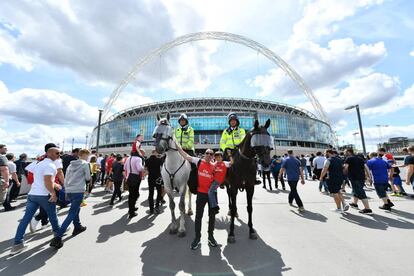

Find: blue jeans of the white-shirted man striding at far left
<box><xmin>14</xmin><ymin>195</ymin><xmax>60</xmax><ymax>244</ymax></box>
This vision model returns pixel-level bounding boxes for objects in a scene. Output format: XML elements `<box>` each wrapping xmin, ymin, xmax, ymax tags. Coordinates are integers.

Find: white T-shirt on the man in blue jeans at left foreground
<box><xmin>27</xmin><ymin>158</ymin><xmax>57</xmax><ymax>196</ymax></box>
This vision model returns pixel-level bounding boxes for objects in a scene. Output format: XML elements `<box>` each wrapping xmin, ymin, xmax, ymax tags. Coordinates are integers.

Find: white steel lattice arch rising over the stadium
<box><xmin>102</xmin><ymin>32</ymin><xmax>336</xmax><ymax>143</ymax></box>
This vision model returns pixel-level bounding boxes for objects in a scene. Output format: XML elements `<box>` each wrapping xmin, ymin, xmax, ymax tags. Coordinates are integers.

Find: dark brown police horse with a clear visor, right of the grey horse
<box><xmin>226</xmin><ymin>119</ymin><xmax>274</xmax><ymax>243</ymax></box>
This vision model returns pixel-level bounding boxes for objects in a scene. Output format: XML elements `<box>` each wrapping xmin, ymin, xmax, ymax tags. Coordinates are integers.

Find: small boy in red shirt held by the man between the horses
<box><xmin>208</xmin><ymin>151</ymin><xmax>232</xmax><ymax>214</ymax></box>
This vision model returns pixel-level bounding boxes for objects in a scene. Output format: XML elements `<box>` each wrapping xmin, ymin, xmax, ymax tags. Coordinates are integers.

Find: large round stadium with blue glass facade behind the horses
<box><xmin>91</xmin><ymin>98</ymin><xmax>333</xmax><ymax>154</ymax></box>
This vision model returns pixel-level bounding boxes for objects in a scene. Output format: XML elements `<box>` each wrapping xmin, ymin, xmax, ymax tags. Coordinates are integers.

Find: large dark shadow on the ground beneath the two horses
<box><xmin>138</xmin><ymin>217</ymin><xmax>290</xmax><ymax>276</ymax></box>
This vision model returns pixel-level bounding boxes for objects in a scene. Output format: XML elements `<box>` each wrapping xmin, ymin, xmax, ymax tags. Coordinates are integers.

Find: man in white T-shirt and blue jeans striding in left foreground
<box><xmin>10</xmin><ymin>147</ymin><xmax>60</xmax><ymax>255</ymax></box>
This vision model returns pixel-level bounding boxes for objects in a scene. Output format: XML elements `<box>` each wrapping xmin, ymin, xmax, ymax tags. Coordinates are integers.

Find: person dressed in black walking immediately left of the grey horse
<box><xmin>145</xmin><ymin>150</ymin><xmax>162</xmax><ymax>214</ymax></box>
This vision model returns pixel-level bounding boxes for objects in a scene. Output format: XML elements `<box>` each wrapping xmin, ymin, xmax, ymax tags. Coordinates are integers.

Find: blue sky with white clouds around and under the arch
<box><xmin>0</xmin><ymin>0</ymin><xmax>414</xmax><ymax>154</ymax></box>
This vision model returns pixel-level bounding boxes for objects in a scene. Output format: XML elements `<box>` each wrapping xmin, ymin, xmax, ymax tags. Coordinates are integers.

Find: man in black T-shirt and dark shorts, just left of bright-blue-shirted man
<box><xmin>344</xmin><ymin>148</ymin><xmax>372</xmax><ymax>214</ymax></box>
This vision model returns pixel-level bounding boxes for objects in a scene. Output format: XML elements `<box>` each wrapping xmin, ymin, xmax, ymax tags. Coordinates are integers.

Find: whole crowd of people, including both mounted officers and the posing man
<box><xmin>0</xmin><ymin>113</ymin><xmax>414</xmax><ymax>255</ymax></box>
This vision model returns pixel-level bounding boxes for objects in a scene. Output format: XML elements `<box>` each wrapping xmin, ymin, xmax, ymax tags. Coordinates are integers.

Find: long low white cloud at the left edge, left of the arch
<box><xmin>0</xmin><ymin>81</ymin><xmax>97</xmax><ymax>126</ymax></box>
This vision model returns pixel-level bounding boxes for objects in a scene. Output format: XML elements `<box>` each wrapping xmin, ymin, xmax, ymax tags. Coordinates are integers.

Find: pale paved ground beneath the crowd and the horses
<box><xmin>0</xmin><ymin>181</ymin><xmax>414</xmax><ymax>276</ymax></box>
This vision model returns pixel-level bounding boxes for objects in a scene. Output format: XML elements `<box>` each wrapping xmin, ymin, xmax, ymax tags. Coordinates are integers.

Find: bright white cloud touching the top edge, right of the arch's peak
<box><xmin>291</xmin><ymin>0</ymin><xmax>384</xmax><ymax>41</ymax></box>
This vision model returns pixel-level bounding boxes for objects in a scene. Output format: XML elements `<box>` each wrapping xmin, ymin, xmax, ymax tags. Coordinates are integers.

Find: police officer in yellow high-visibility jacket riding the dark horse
<box><xmin>220</xmin><ymin>112</ymin><xmax>246</xmax><ymax>160</ymax></box>
